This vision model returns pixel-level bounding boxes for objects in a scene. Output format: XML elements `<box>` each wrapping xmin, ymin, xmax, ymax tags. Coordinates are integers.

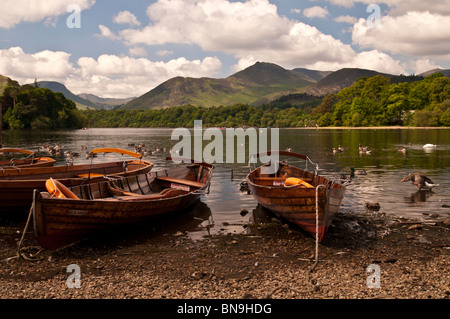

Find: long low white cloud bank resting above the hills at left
<box><xmin>0</xmin><ymin>47</ymin><xmax>222</xmax><ymax>98</ymax></box>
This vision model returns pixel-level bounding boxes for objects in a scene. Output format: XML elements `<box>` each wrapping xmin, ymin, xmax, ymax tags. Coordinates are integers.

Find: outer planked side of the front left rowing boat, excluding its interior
<box><xmin>33</xmin><ymin>192</ymin><xmax>204</xmax><ymax>249</ymax></box>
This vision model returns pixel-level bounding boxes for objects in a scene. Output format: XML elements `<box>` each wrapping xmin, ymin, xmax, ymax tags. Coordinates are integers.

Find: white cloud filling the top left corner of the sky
<box><xmin>0</xmin><ymin>0</ymin><xmax>95</xmax><ymax>28</ymax></box>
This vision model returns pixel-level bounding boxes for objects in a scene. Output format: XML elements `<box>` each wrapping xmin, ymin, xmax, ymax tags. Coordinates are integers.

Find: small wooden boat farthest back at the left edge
<box><xmin>0</xmin><ymin>148</ymin><xmax>56</xmax><ymax>170</ymax></box>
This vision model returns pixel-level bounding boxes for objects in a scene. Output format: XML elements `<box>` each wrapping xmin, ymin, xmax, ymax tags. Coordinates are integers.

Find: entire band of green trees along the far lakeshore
<box><xmin>0</xmin><ymin>73</ymin><xmax>450</xmax><ymax>129</ymax></box>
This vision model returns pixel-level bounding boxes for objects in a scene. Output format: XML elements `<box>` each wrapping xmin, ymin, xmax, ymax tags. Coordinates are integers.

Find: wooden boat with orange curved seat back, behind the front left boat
<box><xmin>0</xmin><ymin>148</ymin><xmax>154</xmax><ymax>218</ymax></box>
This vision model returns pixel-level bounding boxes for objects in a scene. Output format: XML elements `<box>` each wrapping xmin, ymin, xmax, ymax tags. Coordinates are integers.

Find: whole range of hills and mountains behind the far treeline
<box><xmin>0</xmin><ymin>62</ymin><xmax>450</xmax><ymax>109</ymax></box>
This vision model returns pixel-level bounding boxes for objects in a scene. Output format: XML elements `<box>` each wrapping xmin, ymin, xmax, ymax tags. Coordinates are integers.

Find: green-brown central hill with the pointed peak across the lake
<box><xmin>122</xmin><ymin>62</ymin><xmax>314</xmax><ymax>109</ymax></box>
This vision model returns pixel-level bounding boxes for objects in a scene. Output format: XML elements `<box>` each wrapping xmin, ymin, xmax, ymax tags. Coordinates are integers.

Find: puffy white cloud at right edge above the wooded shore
<box><xmin>352</xmin><ymin>12</ymin><xmax>450</xmax><ymax>59</ymax></box>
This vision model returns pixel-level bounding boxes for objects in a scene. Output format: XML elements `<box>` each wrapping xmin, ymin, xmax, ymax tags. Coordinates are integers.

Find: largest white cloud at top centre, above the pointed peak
<box><xmin>118</xmin><ymin>0</ymin><xmax>403</xmax><ymax>71</ymax></box>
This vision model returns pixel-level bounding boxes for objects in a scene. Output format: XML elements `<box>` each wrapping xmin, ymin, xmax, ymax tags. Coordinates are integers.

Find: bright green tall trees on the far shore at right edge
<box><xmin>311</xmin><ymin>73</ymin><xmax>450</xmax><ymax>126</ymax></box>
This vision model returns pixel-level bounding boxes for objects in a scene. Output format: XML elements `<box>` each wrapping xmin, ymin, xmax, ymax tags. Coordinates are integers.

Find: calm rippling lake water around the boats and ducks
<box><xmin>3</xmin><ymin>128</ymin><xmax>450</xmax><ymax>237</ymax></box>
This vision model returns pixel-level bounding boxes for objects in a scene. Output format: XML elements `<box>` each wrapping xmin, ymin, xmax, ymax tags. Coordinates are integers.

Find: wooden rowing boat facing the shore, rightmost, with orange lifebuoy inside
<box><xmin>247</xmin><ymin>151</ymin><xmax>345</xmax><ymax>241</ymax></box>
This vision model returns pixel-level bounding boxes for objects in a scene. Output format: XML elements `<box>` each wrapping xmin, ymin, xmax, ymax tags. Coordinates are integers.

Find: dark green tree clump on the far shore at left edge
<box><xmin>0</xmin><ymin>80</ymin><xmax>87</xmax><ymax>129</ymax></box>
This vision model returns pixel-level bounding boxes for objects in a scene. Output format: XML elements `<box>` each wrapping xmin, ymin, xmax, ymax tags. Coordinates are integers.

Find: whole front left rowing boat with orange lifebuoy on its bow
<box><xmin>32</xmin><ymin>159</ymin><xmax>213</xmax><ymax>249</ymax></box>
